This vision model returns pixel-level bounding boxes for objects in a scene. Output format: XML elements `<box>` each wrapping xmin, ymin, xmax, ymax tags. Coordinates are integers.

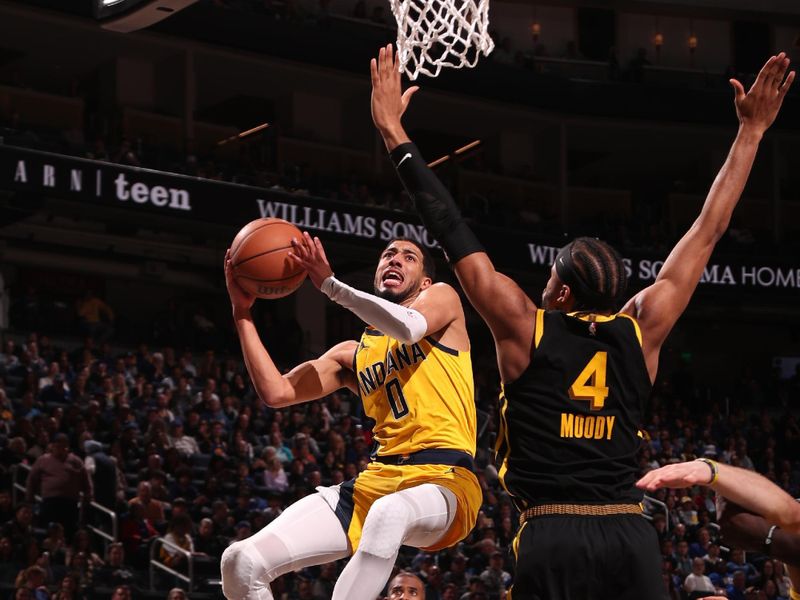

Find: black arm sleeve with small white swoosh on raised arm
<box><xmin>389</xmin><ymin>142</ymin><xmax>484</xmax><ymax>264</ymax></box>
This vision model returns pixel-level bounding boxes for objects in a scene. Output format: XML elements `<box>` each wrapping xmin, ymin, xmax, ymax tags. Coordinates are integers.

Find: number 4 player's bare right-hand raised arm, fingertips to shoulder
<box><xmin>622</xmin><ymin>52</ymin><xmax>794</xmax><ymax>377</ymax></box>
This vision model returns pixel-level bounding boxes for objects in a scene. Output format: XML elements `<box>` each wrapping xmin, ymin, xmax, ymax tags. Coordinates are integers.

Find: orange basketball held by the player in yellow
<box><xmin>231</xmin><ymin>218</ymin><xmax>307</xmax><ymax>300</ymax></box>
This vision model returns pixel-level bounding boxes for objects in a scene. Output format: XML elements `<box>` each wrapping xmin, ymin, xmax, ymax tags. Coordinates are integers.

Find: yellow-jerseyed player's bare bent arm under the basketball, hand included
<box><xmin>220</xmin><ymin>250</ymin><xmax>358</xmax><ymax>408</ymax></box>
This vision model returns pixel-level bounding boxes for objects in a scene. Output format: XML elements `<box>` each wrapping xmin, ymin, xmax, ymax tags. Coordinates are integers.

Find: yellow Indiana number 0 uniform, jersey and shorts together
<box><xmin>328</xmin><ymin>328</ymin><xmax>483</xmax><ymax>552</ymax></box>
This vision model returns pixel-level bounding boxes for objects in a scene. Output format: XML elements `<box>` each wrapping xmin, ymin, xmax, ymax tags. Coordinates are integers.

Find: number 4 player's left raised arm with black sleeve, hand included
<box><xmin>370</xmin><ymin>45</ymin><xmax>536</xmax><ymax>381</ymax></box>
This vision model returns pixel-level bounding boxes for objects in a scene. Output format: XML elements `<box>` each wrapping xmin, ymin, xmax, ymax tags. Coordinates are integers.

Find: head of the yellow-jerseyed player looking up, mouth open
<box><xmin>374</xmin><ymin>238</ymin><xmax>436</xmax><ymax>302</ymax></box>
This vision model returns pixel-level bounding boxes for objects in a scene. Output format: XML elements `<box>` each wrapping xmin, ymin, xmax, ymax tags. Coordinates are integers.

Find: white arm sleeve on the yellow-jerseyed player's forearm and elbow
<box><xmin>320</xmin><ymin>275</ymin><xmax>428</xmax><ymax>344</ymax></box>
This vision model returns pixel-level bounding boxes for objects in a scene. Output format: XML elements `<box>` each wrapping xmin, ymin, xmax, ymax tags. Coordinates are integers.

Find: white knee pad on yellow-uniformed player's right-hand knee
<box><xmin>358</xmin><ymin>495</ymin><xmax>411</xmax><ymax>559</ymax></box>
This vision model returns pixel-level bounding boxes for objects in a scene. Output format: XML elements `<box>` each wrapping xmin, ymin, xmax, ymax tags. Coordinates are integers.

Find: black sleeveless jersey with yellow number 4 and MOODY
<box><xmin>496</xmin><ymin>309</ymin><xmax>651</xmax><ymax>509</ymax></box>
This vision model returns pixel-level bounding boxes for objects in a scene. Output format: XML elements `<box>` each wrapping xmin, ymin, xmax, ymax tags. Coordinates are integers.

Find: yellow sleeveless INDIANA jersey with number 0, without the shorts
<box><xmin>355</xmin><ymin>328</ymin><xmax>476</xmax><ymax>456</ymax></box>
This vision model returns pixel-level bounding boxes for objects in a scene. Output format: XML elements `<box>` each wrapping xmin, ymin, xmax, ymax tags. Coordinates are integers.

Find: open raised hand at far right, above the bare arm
<box><xmin>730</xmin><ymin>52</ymin><xmax>795</xmax><ymax>133</ymax></box>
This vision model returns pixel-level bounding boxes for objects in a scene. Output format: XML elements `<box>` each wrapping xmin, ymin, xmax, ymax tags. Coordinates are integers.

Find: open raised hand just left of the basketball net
<box><xmin>369</xmin><ymin>44</ymin><xmax>419</xmax><ymax>145</ymax></box>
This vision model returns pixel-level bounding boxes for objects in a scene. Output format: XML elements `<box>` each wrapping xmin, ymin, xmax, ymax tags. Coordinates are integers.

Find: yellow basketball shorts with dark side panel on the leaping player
<box><xmin>326</xmin><ymin>462</ymin><xmax>483</xmax><ymax>552</ymax></box>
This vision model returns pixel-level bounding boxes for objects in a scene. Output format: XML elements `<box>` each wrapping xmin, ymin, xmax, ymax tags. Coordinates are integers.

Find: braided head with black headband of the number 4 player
<box><xmin>542</xmin><ymin>237</ymin><xmax>628</xmax><ymax>313</ymax></box>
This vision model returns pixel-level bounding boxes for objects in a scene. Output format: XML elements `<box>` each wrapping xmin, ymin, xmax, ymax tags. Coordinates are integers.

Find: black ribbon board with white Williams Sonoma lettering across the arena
<box><xmin>0</xmin><ymin>145</ymin><xmax>800</xmax><ymax>291</ymax></box>
